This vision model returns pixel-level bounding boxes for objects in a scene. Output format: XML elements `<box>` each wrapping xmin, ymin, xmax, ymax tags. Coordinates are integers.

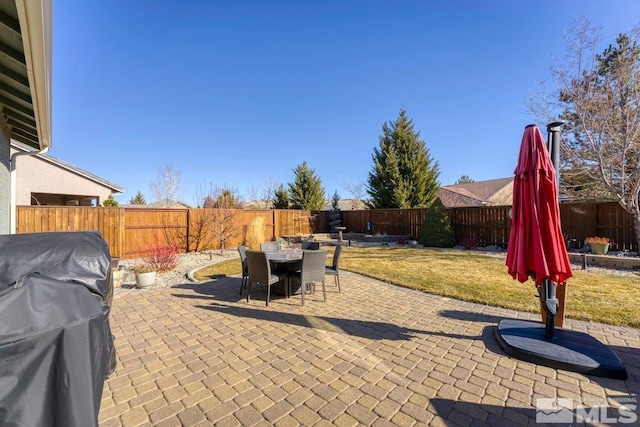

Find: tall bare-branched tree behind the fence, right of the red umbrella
<box><xmin>528</xmin><ymin>18</ymin><xmax>640</xmax><ymax>246</ymax></box>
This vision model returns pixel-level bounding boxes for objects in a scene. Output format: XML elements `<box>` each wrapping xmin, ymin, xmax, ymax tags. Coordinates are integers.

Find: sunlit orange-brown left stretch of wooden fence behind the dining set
<box><xmin>16</xmin><ymin>206</ymin><xmax>319</xmax><ymax>258</ymax></box>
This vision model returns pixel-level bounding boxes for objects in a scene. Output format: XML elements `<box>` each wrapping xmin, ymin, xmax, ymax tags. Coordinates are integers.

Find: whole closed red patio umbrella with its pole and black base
<box><xmin>496</xmin><ymin>122</ymin><xmax>627</xmax><ymax>379</ymax></box>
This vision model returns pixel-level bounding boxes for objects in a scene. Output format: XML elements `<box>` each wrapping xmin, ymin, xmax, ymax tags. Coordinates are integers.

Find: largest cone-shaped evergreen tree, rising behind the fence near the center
<box><xmin>367</xmin><ymin>109</ymin><xmax>440</xmax><ymax>209</ymax></box>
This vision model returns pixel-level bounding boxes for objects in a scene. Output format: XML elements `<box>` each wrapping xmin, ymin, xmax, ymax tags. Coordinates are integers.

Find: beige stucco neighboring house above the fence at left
<box><xmin>11</xmin><ymin>145</ymin><xmax>123</xmax><ymax>206</ymax></box>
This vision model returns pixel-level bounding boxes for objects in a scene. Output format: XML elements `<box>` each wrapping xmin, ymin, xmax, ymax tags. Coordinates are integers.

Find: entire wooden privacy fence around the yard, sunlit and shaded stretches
<box><xmin>16</xmin><ymin>202</ymin><xmax>638</xmax><ymax>258</ymax></box>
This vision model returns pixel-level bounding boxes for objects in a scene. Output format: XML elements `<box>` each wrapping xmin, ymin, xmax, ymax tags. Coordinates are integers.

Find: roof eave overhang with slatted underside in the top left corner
<box><xmin>0</xmin><ymin>0</ymin><xmax>52</xmax><ymax>150</ymax></box>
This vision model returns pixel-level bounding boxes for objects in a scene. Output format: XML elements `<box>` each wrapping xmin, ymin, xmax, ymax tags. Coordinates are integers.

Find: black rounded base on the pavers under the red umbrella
<box><xmin>496</xmin><ymin>319</ymin><xmax>627</xmax><ymax>380</ymax></box>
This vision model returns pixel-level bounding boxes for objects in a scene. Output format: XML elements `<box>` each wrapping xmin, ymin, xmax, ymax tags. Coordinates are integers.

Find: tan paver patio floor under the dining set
<box><xmin>99</xmin><ymin>272</ymin><xmax>640</xmax><ymax>427</ymax></box>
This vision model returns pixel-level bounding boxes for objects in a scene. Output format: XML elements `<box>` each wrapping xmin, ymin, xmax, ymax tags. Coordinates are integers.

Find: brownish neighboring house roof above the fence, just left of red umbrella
<box><xmin>439</xmin><ymin>178</ymin><xmax>513</xmax><ymax>208</ymax></box>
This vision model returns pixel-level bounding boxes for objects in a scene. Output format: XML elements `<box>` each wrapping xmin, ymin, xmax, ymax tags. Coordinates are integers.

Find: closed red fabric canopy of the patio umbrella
<box><xmin>506</xmin><ymin>126</ymin><xmax>573</xmax><ymax>286</ymax></box>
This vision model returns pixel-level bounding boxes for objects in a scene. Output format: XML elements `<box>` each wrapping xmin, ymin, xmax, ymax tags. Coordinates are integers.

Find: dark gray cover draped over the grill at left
<box><xmin>0</xmin><ymin>232</ymin><xmax>115</xmax><ymax>427</ymax></box>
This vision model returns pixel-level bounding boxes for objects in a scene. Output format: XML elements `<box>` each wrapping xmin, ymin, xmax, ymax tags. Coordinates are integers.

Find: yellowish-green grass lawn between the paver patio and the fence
<box><xmin>196</xmin><ymin>246</ymin><xmax>640</xmax><ymax>328</ymax></box>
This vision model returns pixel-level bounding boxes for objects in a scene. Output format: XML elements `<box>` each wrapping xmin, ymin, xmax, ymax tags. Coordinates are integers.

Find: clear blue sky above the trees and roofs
<box><xmin>49</xmin><ymin>0</ymin><xmax>640</xmax><ymax>204</ymax></box>
